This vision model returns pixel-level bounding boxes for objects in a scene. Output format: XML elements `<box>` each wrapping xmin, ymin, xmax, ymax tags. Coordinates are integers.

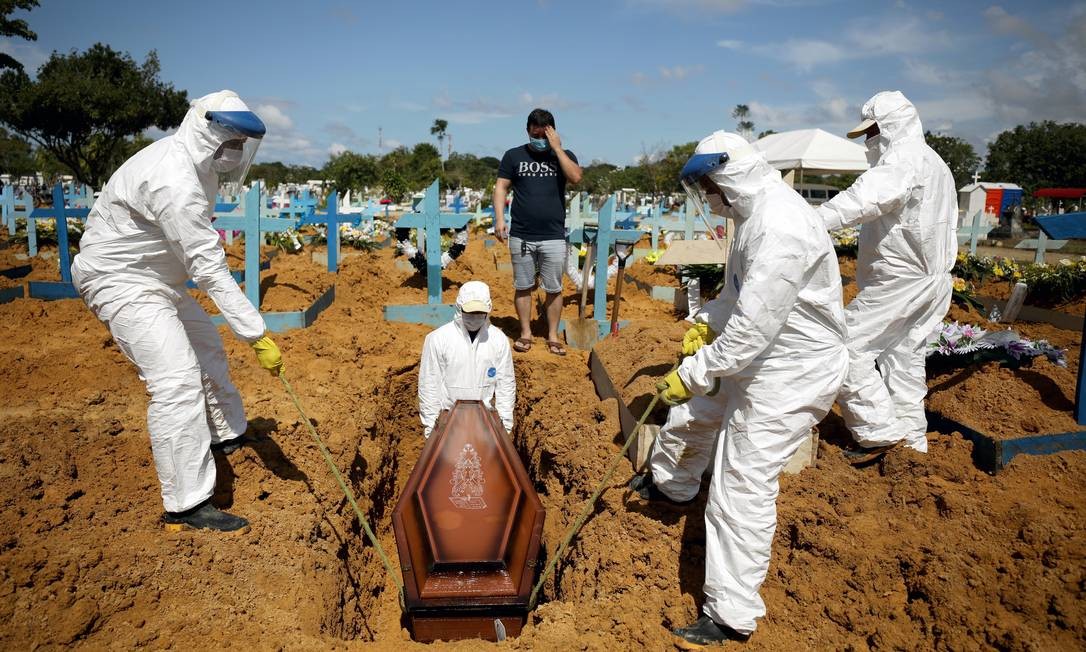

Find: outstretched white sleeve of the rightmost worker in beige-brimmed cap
<box><xmin>816</xmin><ymin>163</ymin><xmax>914</xmax><ymax>230</ymax></box>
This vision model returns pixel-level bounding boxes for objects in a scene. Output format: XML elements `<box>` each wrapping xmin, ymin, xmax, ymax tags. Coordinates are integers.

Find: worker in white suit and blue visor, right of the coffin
<box><xmin>631</xmin><ymin>131</ymin><xmax>848</xmax><ymax>644</ymax></box>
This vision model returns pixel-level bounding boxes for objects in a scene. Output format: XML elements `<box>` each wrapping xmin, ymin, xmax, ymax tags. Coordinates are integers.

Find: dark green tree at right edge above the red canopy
<box><xmin>984</xmin><ymin>121</ymin><xmax>1086</xmax><ymax>195</ymax></box>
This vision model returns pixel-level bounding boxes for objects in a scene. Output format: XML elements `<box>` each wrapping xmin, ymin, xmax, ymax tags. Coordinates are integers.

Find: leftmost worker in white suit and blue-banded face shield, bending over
<box><xmin>72</xmin><ymin>90</ymin><xmax>282</xmax><ymax>531</ymax></box>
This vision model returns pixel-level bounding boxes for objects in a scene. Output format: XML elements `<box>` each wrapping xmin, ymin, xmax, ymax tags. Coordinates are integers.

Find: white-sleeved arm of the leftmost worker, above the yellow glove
<box><xmin>148</xmin><ymin>179</ymin><xmax>266</xmax><ymax>343</ymax></box>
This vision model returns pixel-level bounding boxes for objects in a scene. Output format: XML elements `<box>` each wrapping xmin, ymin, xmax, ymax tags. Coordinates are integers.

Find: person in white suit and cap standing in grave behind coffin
<box><xmin>418</xmin><ymin>280</ymin><xmax>517</xmax><ymax>437</ymax></box>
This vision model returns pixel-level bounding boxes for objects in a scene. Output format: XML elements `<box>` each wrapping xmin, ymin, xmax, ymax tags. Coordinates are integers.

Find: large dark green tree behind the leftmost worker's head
<box><xmin>0</xmin><ymin>43</ymin><xmax>188</xmax><ymax>188</ymax></box>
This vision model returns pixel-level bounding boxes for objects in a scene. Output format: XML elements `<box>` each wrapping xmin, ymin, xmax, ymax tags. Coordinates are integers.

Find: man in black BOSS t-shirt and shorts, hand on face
<box><xmin>494</xmin><ymin>109</ymin><xmax>581</xmax><ymax>355</ymax></box>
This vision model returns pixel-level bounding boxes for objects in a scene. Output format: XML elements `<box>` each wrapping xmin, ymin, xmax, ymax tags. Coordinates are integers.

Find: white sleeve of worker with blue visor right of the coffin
<box><xmin>679</xmin><ymin>221</ymin><xmax>807</xmax><ymax>394</ymax></box>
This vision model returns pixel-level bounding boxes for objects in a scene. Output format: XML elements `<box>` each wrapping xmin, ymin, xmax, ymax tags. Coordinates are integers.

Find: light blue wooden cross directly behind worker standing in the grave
<box><xmin>384</xmin><ymin>179</ymin><xmax>471</xmax><ymax>326</ymax></box>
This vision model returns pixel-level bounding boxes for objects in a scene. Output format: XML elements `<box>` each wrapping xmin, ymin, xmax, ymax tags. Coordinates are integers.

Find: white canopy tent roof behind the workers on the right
<box><xmin>754</xmin><ymin>129</ymin><xmax>868</xmax><ymax>181</ymax></box>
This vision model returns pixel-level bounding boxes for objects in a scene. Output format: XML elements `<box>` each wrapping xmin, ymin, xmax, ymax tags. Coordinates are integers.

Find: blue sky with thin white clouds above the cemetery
<box><xmin>8</xmin><ymin>0</ymin><xmax>1086</xmax><ymax>165</ymax></box>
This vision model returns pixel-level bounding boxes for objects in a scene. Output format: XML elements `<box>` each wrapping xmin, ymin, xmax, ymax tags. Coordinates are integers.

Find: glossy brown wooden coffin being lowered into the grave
<box><xmin>392</xmin><ymin>401</ymin><xmax>544</xmax><ymax>641</ymax></box>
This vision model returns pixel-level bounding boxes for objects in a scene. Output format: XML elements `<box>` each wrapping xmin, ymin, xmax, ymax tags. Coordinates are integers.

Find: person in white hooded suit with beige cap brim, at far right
<box><xmin>818</xmin><ymin>90</ymin><xmax>958</xmax><ymax>464</ymax></box>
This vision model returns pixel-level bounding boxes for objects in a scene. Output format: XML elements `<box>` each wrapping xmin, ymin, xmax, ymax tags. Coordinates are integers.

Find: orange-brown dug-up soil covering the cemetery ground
<box><xmin>0</xmin><ymin>236</ymin><xmax>1086</xmax><ymax>650</ymax></box>
